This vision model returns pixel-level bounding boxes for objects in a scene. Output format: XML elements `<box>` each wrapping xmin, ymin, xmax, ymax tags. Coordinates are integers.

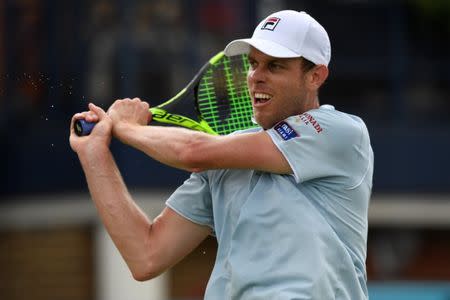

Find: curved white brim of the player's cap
<box><xmin>224</xmin><ymin>38</ymin><xmax>301</xmax><ymax>58</ymax></box>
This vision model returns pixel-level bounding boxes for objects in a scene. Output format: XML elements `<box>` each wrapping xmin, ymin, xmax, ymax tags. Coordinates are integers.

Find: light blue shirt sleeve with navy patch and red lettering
<box><xmin>267</xmin><ymin>109</ymin><xmax>368</xmax><ymax>188</ymax></box>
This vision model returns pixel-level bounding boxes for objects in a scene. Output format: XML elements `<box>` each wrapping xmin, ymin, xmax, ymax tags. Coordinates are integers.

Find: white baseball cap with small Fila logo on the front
<box><xmin>224</xmin><ymin>10</ymin><xmax>331</xmax><ymax>66</ymax></box>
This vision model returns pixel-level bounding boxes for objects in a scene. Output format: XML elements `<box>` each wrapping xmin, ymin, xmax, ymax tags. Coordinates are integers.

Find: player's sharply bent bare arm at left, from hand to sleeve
<box><xmin>70</xmin><ymin>105</ymin><xmax>211</xmax><ymax>280</ymax></box>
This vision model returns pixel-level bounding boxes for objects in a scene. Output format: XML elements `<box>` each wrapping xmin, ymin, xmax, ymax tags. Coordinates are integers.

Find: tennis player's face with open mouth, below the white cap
<box><xmin>247</xmin><ymin>48</ymin><xmax>312</xmax><ymax>129</ymax></box>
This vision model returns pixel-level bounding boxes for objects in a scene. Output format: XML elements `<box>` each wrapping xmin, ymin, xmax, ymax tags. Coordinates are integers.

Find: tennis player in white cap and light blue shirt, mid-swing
<box><xmin>70</xmin><ymin>11</ymin><xmax>373</xmax><ymax>300</ymax></box>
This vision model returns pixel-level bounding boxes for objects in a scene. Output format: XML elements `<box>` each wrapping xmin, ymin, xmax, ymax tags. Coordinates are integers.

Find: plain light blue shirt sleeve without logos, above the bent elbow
<box><xmin>166</xmin><ymin>173</ymin><xmax>214</xmax><ymax>230</ymax></box>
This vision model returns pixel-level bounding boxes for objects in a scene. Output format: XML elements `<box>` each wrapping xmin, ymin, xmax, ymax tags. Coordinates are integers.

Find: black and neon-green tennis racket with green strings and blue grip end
<box><xmin>74</xmin><ymin>52</ymin><xmax>257</xmax><ymax>136</ymax></box>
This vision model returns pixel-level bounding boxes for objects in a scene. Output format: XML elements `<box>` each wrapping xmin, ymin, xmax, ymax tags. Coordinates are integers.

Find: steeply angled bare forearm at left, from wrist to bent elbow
<box><xmin>79</xmin><ymin>149</ymin><xmax>152</xmax><ymax>273</ymax></box>
